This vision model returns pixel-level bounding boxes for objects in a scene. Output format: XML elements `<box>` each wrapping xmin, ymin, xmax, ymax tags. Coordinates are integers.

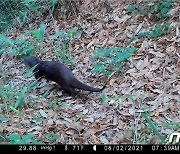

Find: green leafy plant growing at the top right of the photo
<box><xmin>126</xmin><ymin>0</ymin><xmax>175</xmax><ymax>41</ymax></box>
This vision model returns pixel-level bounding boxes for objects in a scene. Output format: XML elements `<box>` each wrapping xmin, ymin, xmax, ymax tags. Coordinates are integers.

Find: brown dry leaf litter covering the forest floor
<box><xmin>0</xmin><ymin>0</ymin><xmax>180</xmax><ymax>144</ymax></box>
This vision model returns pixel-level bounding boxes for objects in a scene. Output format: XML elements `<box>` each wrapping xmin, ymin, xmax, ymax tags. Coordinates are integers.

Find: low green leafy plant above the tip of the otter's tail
<box><xmin>92</xmin><ymin>47</ymin><xmax>137</xmax><ymax>76</ymax></box>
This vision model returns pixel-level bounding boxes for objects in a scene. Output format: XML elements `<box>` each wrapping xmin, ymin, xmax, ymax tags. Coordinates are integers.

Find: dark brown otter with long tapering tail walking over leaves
<box><xmin>24</xmin><ymin>56</ymin><xmax>106</xmax><ymax>96</ymax></box>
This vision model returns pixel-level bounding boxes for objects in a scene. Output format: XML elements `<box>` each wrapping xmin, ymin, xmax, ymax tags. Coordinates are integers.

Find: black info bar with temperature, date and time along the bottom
<box><xmin>0</xmin><ymin>144</ymin><xmax>180</xmax><ymax>153</ymax></box>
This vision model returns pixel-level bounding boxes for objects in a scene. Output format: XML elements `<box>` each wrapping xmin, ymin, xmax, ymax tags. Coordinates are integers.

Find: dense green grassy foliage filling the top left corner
<box><xmin>0</xmin><ymin>0</ymin><xmax>54</xmax><ymax>32</ymax></box>
